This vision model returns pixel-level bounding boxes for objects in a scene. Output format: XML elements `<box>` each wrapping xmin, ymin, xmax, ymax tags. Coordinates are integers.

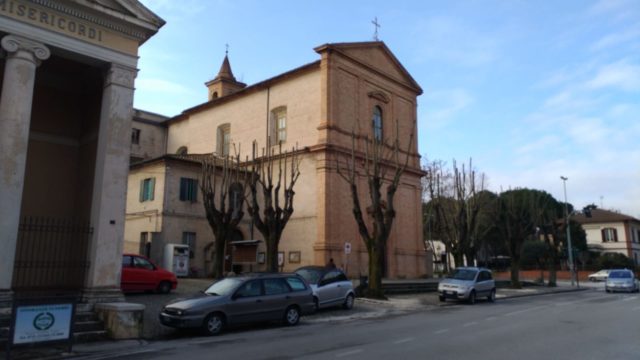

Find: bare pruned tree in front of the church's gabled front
<box><xmin>335</xmin><ymin>123</ymin><xmax>413</xmax><ymax>298</ymax></box>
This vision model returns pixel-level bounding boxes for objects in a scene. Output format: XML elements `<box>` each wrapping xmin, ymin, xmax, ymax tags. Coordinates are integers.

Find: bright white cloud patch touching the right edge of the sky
<box><xmin>585</xmin><ymin>59</ymin><xmax>640</xmax><ymax>91</ymax></box>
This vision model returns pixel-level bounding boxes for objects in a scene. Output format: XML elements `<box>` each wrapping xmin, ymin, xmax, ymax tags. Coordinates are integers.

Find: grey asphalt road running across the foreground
<box><xmin>81</xmin><ymin>287</ymin><xmax>640</xmax><ymax>360</ymax></box>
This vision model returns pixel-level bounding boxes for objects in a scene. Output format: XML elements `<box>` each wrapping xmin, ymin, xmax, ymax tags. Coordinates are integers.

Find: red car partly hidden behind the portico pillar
<box><xmin>120</xmin><ymin>254</ymin><xmax>178</xmax><ymax>294</ymax></box>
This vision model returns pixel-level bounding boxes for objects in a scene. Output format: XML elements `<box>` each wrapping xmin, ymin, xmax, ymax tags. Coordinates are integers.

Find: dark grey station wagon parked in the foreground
<box><xmin>159</xmin><ymin>273</ymin><xmax>314</xmax><ymax>335</ymax></box>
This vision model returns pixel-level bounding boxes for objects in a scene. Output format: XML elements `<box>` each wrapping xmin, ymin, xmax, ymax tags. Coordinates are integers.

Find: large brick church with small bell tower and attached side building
<box><xmin>124</xmin><ymin>41</ymin><xmax>432</xmax><ymax>278</ymax></box>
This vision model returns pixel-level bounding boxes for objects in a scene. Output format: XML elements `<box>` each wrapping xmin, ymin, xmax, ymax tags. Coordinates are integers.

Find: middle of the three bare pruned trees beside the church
<box><xmin>246</xmin><ymin>142</ymin><xmax>300</xmax><ymax>272</ymax></box>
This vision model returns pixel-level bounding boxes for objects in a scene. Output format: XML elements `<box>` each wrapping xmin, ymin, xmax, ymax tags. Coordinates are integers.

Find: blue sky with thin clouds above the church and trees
<box><xmin>134</xmin><ymin>0</ymin><xmax>640</xmax><ymax>218</ymax></box>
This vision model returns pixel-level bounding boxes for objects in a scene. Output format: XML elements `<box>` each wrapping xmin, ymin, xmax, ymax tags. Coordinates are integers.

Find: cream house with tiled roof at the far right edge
<box><xmin>574</xmin><ymin>209</ymin><xmax>640</xmax><ymax>265</ymax></box>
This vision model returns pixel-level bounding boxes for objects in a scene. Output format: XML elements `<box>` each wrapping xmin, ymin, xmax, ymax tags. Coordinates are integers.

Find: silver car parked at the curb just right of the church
<box><xmin>438</xmin><ymin>267</ymin><xmax>496</xmax><ymax>304</ymax></box>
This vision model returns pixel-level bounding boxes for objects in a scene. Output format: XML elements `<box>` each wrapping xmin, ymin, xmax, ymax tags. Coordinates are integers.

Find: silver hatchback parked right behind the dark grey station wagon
<box><xmin>295</xmin><ymin>266</ymin><xmax>356</xmax><ymax>310</ymax></box>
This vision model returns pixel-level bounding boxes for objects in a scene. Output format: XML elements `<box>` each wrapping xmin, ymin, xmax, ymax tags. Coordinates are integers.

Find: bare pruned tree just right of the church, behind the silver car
<box><xmin>423</xmin><ymin>159</ymin><xmax>488</xmax><ymax>266</ymax></box>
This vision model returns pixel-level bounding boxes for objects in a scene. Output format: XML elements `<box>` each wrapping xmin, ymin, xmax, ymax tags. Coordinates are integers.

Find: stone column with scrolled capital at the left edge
<box><xmin>0</xmin><ymin>35</ymin><xmax>50</xmax><ymax>303</ymax></box>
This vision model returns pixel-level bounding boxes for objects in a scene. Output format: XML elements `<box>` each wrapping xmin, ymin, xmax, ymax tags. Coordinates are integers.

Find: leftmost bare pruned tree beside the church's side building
<box><xmin>200</xmin><ymin>154</ymin><xmax>250</xmax><ymax>279</ymax></box>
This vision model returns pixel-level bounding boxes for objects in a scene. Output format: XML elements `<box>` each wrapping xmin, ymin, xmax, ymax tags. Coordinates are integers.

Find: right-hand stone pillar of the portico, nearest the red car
<box><xmin>83</xmin><ymin>64</ymin><xmax>137</xmax><ymax>303</ymax></box>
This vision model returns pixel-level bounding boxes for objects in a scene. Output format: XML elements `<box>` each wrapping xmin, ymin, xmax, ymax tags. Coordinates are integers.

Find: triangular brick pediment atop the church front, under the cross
<box><xmin>315</xmin><ymin>41</ymin><xmax>422</xmax><ymax>94</ymax></box>
